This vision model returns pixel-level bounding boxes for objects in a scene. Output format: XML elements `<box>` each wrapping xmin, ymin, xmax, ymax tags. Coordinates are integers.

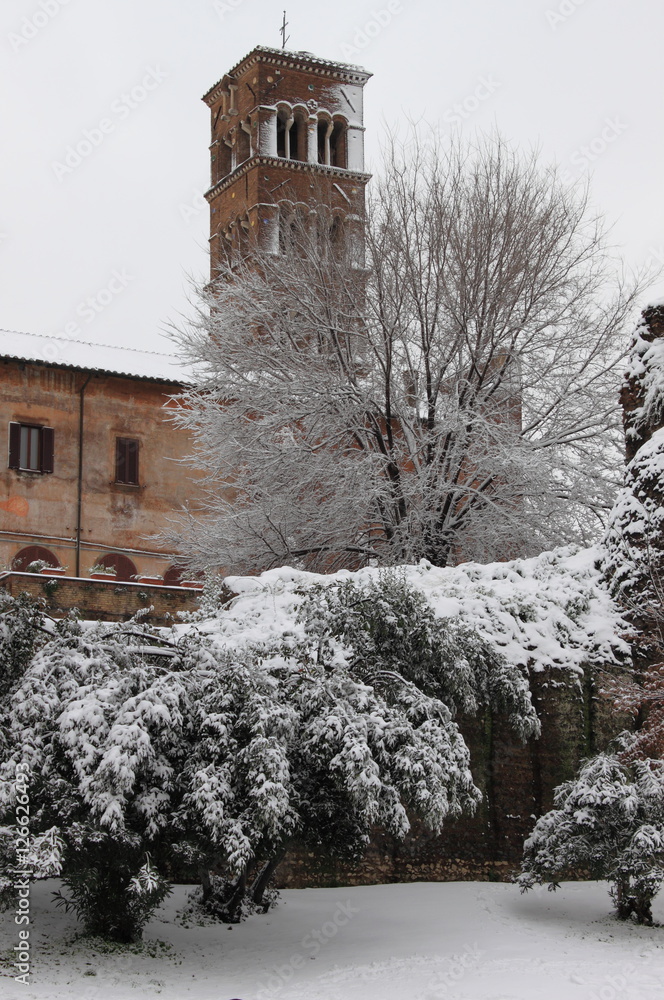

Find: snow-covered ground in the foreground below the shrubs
<box><xmin>0</xmin><ymin>882</ymin><xmax>664</xmax><ymax>1000</ymax></box>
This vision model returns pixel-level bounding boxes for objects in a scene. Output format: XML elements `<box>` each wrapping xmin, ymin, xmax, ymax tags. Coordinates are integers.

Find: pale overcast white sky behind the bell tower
<box><xmin>0</xmin><ymin>0</ymin><xmax>664</xmax><ymax>358</ymax></box>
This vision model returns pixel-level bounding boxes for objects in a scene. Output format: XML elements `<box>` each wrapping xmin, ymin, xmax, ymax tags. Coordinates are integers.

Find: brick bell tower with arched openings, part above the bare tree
<box><xmin>203</xmin><ymin>46</ymin><xmax>371</xmax><ymax>277</ymax></box>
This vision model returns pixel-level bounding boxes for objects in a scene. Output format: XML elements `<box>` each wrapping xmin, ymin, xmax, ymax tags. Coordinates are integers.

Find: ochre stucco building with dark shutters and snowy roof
<box><xmin>0</xmin><ymin>332</ymin><xmax>202</xmax><ymax>617</ymax></box>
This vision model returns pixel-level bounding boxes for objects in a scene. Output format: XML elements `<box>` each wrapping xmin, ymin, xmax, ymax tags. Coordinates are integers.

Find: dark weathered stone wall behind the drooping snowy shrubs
<box><xmin>277</xmin><ymin>670</ymin><xmax>630</xmax><ymax>888</ymax></box>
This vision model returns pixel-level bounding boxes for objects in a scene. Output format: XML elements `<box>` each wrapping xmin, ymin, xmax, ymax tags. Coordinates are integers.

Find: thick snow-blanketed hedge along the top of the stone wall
<box><xmin>187</xmin><ymin>546</ymin><xmax>629</xmax><ymax>679</ymax></box>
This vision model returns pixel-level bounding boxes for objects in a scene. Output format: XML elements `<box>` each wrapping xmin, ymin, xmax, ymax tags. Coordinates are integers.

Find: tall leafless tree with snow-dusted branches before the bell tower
<box><xmin>170</xmin><ymin>138</ymin><xmax>638</xmax><ymax>572</ymax></box>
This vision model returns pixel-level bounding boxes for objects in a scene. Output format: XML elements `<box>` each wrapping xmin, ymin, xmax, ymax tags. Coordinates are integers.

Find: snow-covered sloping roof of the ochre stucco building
<box><xmin>0</xmin><ymin>330</ymin><xmax>191</xmax><ymax>385</ymax></box>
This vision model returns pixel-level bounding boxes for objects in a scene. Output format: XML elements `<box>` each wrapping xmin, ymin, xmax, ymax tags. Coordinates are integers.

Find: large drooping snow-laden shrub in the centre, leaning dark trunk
<box><xmin>175</xmin><ymin>624</ymin><xmax>488</xmax><ymax>920</ymax></box>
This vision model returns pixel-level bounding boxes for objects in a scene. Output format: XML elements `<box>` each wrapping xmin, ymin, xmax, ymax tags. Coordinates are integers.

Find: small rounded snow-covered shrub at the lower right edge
<box><xmin>518</xmin><ymin>752</ymin><xmax>664</xmax><ymax>924</ymax></box>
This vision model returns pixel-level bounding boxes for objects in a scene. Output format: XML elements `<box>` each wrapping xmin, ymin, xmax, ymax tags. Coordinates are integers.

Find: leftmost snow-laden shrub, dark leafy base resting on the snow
<box><xmin>0</xmin><ymin>621</ymin><xmax>185</xmax><ymax>940</ymax></box>
